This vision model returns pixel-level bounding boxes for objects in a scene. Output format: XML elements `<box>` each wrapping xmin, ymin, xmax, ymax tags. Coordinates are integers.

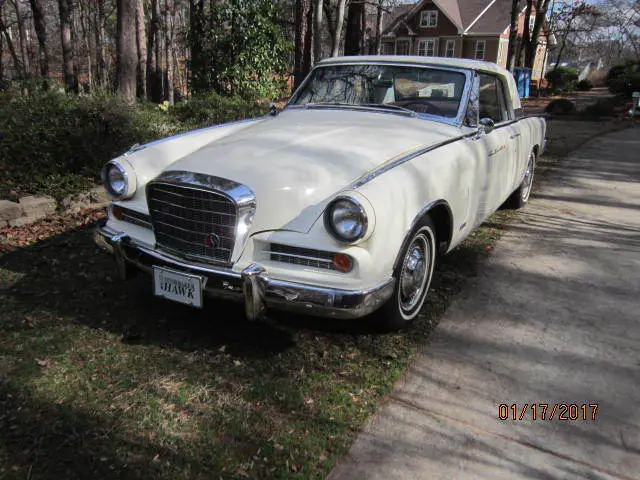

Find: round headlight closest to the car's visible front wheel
<box><xmin>324</xmin><ymin>197</ymin><xmax>368</xmax><ymax>243</ymax></box>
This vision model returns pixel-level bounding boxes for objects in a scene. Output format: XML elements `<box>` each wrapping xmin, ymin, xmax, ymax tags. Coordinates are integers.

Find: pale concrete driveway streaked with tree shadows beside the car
<box><xmin>330</xmin><ymin>128</ymin><xmax>640</xmax><ymax>480</ymax></box>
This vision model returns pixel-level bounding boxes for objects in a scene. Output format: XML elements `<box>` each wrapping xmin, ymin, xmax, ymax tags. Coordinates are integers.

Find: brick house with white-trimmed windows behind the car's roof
<box><xmin>381</xmin><ymin>0</ymin><xmax>553</xmax><ymax>81</ymax></box>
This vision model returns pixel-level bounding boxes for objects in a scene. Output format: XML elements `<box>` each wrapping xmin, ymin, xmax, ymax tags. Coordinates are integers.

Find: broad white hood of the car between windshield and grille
<box><xmin>166</xmin><ymin>108</ymin><xmax>460</xmax><ymax>232</ymax></box>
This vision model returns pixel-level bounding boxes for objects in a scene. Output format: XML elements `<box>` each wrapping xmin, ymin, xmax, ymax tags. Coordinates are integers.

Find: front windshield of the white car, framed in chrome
<box><xmin>289</xmin><ymin>65</ymin><xmax>466</xmax><ymax>118</ymax></box>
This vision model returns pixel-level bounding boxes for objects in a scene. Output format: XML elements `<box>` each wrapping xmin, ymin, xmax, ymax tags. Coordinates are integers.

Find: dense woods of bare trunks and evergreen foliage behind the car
<box><xmin>0</xmin><ymin>0</ymin><xmax>397</xmax><ymax>104</ymax></box>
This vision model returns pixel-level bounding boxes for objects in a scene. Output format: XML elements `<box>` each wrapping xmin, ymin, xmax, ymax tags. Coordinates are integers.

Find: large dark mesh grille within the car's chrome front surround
<box><xmin>147</xmin><ymin>182</ymin><xmax>237</xmax><ymax>263</ymax></box>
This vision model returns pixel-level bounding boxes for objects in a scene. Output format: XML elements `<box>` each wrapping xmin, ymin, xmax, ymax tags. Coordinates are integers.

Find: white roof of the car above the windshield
<box><xmin>318</xmin><ymin>55</ymin><xmax>509</xmax><ymax>75</ymax></box>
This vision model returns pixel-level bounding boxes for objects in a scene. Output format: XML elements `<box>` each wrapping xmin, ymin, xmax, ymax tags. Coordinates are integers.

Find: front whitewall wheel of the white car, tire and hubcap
<box><xmin>375</xmin><ymin>218</ymin><xmax>437</xmax><ymax>330</ymax></box>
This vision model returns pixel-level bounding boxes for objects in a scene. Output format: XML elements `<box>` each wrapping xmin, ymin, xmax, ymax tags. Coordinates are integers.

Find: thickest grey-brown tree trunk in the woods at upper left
<box><xmin>116</xmin><ymin>0</ymin><xmax>138</xmax><ymax>103</ymax></box>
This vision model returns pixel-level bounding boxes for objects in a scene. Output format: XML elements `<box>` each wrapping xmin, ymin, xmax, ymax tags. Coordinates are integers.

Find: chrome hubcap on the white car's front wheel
<box><xmin>400</xmin><ymin>234</ymin><xmax>431</xmax><ymax>311</ymax></box>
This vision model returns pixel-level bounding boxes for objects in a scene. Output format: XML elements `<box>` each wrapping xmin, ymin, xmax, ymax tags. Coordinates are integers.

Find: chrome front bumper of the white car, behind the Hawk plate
<box><xmin>94</xmin><ymin>226</ymin><xmax>395</xmax><ymax>320</ymax></box>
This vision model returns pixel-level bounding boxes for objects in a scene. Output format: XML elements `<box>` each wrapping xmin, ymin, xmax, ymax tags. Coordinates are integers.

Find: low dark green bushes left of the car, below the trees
<box><xmin>0</xmin><ymin>89</ymin><xmax>267</xmax><ymax>198</ymax></box>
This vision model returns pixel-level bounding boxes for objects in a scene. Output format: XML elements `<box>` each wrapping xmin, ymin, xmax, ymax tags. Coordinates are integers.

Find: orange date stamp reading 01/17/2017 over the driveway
<box><xmin>498</xmin><ymin>403</ymin><xmax>600</xmax><ymax>421</ymax></box>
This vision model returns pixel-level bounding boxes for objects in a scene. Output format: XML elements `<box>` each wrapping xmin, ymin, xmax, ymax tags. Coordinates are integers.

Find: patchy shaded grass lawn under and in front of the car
<box><xmin>0</xmin><ymin>117</ymin><xmax>624</xmax><ymax>479</ymax></box>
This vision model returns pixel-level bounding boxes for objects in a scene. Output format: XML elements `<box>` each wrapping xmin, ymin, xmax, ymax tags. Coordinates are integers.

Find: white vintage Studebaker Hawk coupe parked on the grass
<box><xmin>95</xmin><ymin>56</ymin><xmax>545</xmax><ymax>328</ymax></box>
